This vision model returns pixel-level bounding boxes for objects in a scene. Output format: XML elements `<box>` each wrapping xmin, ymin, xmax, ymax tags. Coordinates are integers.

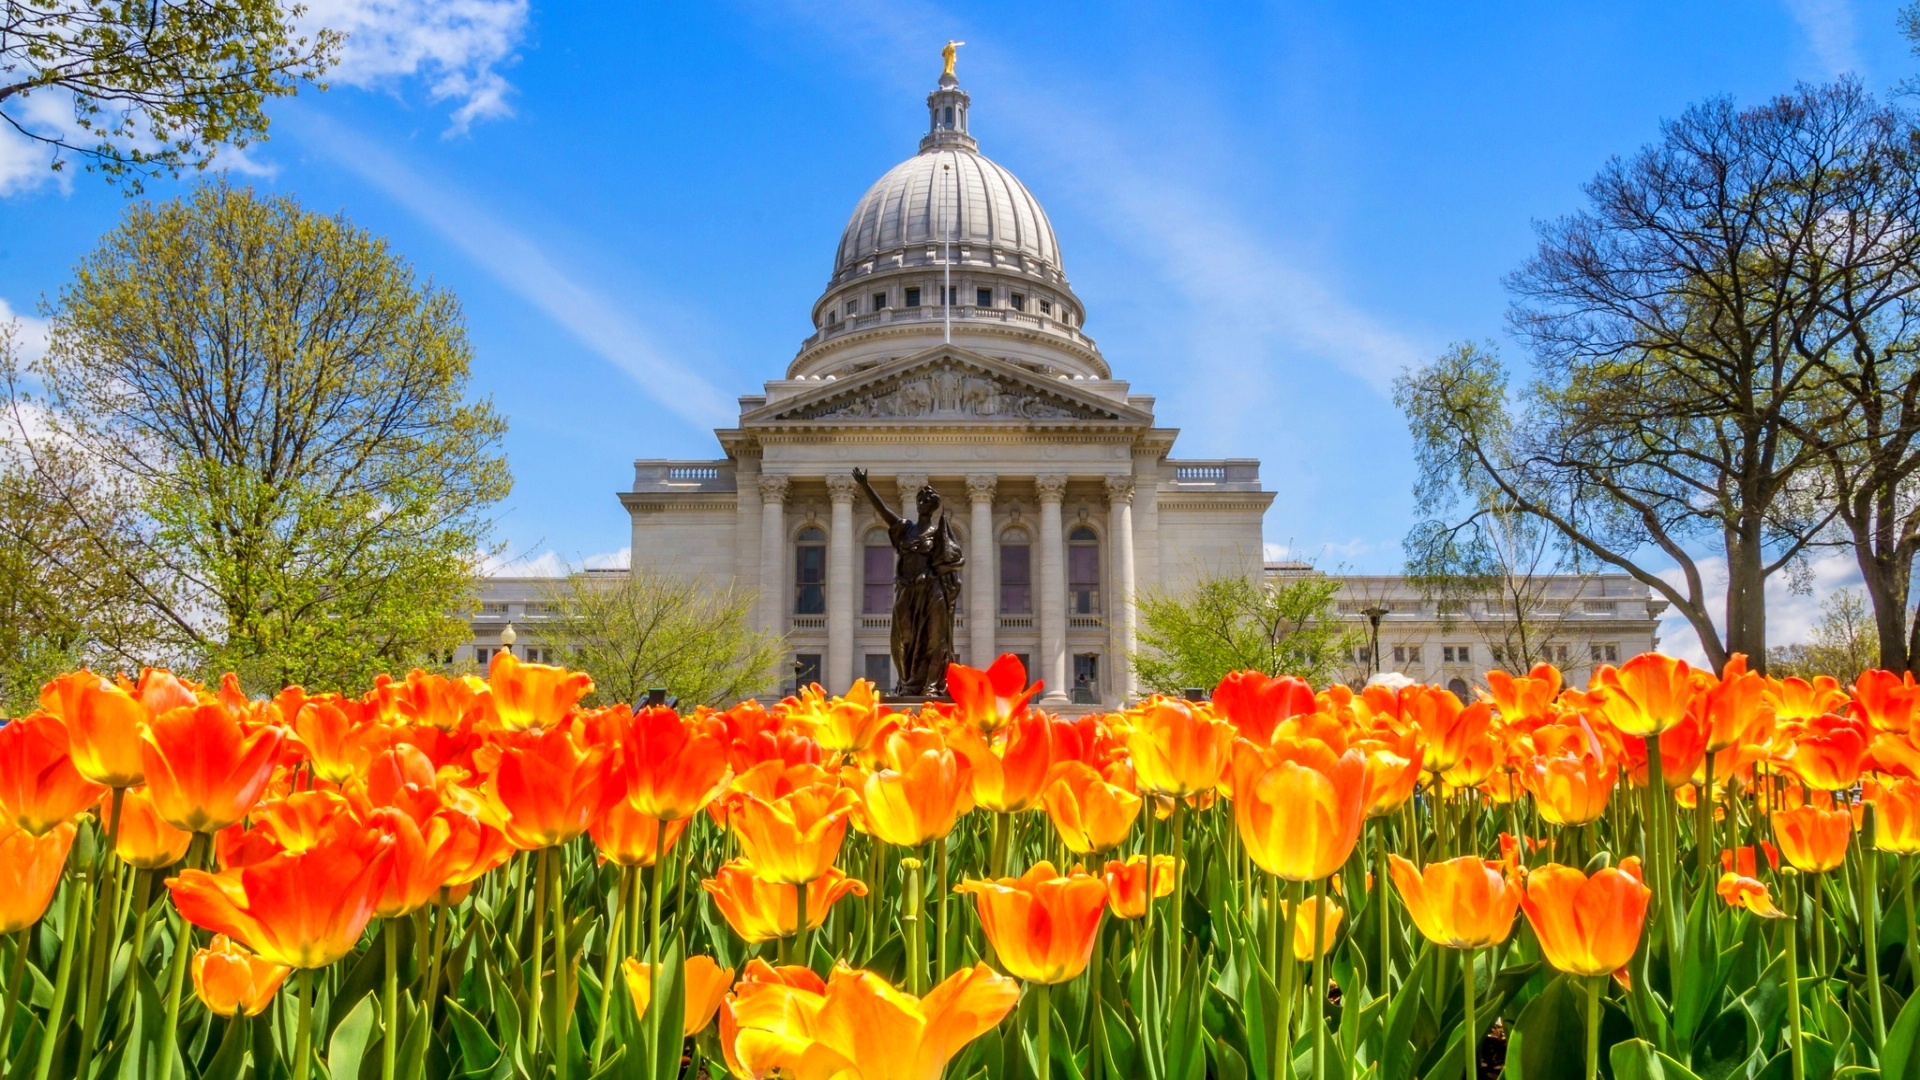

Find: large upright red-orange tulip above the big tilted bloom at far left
<box><xmin>140</xmin><ymin>701</ymin><xmax>286</xmax><ymax>832</ymax></box>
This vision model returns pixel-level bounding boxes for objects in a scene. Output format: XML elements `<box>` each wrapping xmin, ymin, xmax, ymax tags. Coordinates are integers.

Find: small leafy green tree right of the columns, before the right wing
<box><xmin>1133</xmin><ymin>571</ymin><xmax>1361</xmax><ymax>694</ymax></box>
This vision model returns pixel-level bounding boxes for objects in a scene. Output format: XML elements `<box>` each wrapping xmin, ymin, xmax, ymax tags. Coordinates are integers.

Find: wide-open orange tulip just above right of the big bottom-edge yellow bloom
<box><xmin>954</xmin><ymin>859</ymin><xmax>1106</xmax><ymax>984</ymax></box>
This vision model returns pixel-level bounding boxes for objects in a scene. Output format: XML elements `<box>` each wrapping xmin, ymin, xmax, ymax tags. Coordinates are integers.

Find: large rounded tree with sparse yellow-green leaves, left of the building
<box><xmin>27</xmin><ymin>183</ymin><xmax>511</xmax><ymax>690</ymax></box>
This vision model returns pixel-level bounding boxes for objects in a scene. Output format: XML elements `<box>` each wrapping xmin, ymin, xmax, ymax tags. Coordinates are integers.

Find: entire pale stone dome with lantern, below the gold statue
<box><xmin>787</xmin><ymin>67</ymin><xmax>1110</xmax><ymax>379</ymax></box>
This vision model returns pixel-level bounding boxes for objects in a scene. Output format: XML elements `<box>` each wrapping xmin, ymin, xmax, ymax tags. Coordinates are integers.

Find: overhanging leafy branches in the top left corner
<box><xmin>0</xmin><ymin>0</ymin><xmax>340</xmax><ymax>190</ymax></box>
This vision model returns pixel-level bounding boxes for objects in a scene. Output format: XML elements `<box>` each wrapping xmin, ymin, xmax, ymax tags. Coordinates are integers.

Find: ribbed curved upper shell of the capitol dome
<box><xmin>833</xmin><ymin>148</ymin><xmax>1060</xmax><ymax>282</ymax></box>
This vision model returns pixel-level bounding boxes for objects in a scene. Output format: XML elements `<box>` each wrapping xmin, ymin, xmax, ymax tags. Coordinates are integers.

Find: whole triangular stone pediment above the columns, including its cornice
<box><xmin>741</xmin><ymin>346</ymin><xmax>1152</xmax><ymax>425</ymax></box>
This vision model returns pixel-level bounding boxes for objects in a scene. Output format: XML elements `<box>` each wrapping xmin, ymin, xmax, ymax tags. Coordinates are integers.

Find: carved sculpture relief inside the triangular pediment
<box><xmin>787</xmin><ymin>363</ymin><xmax>1116</xmax><ymax>421</ymax></box>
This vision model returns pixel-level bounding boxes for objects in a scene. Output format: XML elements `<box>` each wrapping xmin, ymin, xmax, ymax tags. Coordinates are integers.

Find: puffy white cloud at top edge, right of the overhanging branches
<box><xmin>301</xmin><ymin>0</ymin><xmax>526</xmax><ymax>135</ymax></box>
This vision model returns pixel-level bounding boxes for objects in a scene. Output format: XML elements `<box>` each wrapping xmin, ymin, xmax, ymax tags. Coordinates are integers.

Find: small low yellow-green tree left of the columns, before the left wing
<box><xmin>541</xmin><ymin>569</ymin><xmax>787</xmax><ymax>707</ymax></box>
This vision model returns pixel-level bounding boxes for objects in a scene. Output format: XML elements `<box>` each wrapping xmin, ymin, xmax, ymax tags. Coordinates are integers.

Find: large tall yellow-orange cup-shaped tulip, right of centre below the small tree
<box><xmin>1233</xmin><ymin>740</ymin><xmax>1373</xmax><ymax>882</ymax></box>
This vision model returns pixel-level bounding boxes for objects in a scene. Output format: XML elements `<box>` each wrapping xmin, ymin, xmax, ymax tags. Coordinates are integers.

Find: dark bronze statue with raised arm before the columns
<box><xmin>852</xmin><ymin>469</ymin><xmax>966</xmax><ymax>698</ymax></box>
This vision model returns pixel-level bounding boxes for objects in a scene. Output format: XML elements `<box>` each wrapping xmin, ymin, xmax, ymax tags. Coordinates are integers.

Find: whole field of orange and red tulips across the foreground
<box><xmin>0</xmin><ymin>653</ymin><xmax>1920</xmax><ymax>1080</ymax></box>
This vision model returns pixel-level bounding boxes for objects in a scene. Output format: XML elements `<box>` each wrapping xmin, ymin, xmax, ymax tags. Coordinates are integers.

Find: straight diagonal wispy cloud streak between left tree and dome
<box><xmin>305</xmin><ymin>115</ymin><xmax>735</xmax><ymax>429</ymax></box>
